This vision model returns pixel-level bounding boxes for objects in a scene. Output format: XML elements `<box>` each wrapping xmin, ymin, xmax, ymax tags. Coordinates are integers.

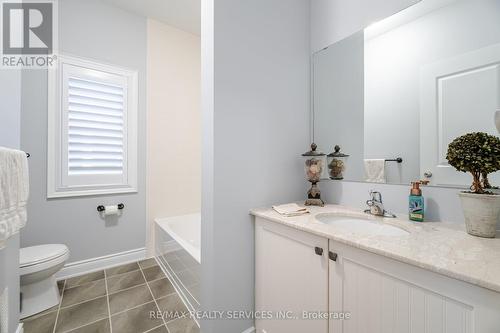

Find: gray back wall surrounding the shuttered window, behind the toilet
<box><xmin>21</xmin><ymin>0</ymin><xmax>146</xmax><ymax>262</ymax></box>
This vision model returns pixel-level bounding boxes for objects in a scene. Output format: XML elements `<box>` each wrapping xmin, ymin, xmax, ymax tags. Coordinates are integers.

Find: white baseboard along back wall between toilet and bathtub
<box><xmin>56</xmin><ymin>247</ymin><xmax>146</xmax><ymax>280</ymax></box>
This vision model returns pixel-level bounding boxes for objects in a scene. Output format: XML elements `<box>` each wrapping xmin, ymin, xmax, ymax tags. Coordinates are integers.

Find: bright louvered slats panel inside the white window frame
<box><xmin>68</xmin><ymin>77</ymin><xmax>124</xmax><ymax>175</ymax></box>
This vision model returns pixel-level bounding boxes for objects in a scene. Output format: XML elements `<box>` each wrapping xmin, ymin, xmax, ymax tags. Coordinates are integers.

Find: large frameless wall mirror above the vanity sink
<box><xmin>312</xmin><ymin>0</ymin><xmax>500</xmax><ymax>187</ymax></box>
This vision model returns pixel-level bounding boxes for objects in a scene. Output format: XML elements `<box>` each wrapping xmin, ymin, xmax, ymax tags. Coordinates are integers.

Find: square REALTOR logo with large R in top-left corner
<box><xmin>1</xmin><ymin>0</ymin><xmax>57</xmax><ymax>68</ymax></box>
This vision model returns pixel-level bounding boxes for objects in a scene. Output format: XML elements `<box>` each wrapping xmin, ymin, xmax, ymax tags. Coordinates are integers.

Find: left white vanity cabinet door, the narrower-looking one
<box><xmin>255</xmin><ymin>218</ymin><xmax>328</xmax><ymax>333</ymax></box>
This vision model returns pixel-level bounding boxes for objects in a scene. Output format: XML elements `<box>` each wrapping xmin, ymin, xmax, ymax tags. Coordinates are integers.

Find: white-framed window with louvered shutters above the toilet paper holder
<box><xmin>47</xmin><ymin>56</ymin><xmax>137</xmax><ymax>198</ymax></box>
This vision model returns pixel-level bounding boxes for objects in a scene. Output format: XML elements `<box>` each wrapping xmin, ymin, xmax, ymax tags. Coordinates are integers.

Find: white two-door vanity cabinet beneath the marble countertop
<box><xmin>255</xmin><ymin>217</ymin><xmax>500</xmax><ymax>333</ymax></box>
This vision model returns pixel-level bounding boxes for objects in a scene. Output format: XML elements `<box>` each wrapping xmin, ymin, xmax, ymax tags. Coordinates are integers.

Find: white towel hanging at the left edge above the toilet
<box><xmin>0</xmin><ymin>147</ymin><xmax>29</xmax><ymax>249</ymax></box>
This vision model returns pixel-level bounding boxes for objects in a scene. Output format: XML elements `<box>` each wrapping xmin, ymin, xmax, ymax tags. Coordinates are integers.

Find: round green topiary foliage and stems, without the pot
<box><xmin>446</xmin><ymin>132</ymin><xmax>500</xmax><ymax>194</ymax></box>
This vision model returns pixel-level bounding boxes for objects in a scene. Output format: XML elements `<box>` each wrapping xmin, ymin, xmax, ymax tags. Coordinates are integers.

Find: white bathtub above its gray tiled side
<box><xmin>155</xmin><ymin>213</ymin><xmax>201</xmax><ymax>263</ymax></box>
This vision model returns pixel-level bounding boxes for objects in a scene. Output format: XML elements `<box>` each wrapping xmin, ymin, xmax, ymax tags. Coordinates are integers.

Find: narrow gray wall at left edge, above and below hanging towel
<box><xmin>0</xmin><ymin>69</ymin><xmax>21</xmax><ymax>332</ymax></box>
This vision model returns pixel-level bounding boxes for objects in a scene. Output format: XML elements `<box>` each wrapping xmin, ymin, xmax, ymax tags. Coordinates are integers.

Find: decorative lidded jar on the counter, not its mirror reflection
<box><xmin>302</xmin><ymin>143</ymin><xmax>325</xmax><ymax>207</ymax></box>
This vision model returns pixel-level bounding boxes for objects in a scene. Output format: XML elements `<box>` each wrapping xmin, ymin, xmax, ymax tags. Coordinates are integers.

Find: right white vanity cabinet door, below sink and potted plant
<box><xmin>329</xmin><ymin>241</ymin><xmax>500</xmax><ymax>333</ymax></box>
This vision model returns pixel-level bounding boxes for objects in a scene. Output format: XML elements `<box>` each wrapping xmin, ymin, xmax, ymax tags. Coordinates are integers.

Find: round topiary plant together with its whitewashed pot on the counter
<box><xmin>446</xmin><ymin>133</ymin><xmax>500</xmax><ymax>238</ymax></box>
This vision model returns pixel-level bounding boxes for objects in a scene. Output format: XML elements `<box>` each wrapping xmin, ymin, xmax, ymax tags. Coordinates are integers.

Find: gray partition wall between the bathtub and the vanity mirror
<box><xmin>201</xmin><ymin>0</ymin><xmax>309</xmax><ymax>333</ymax></box>
